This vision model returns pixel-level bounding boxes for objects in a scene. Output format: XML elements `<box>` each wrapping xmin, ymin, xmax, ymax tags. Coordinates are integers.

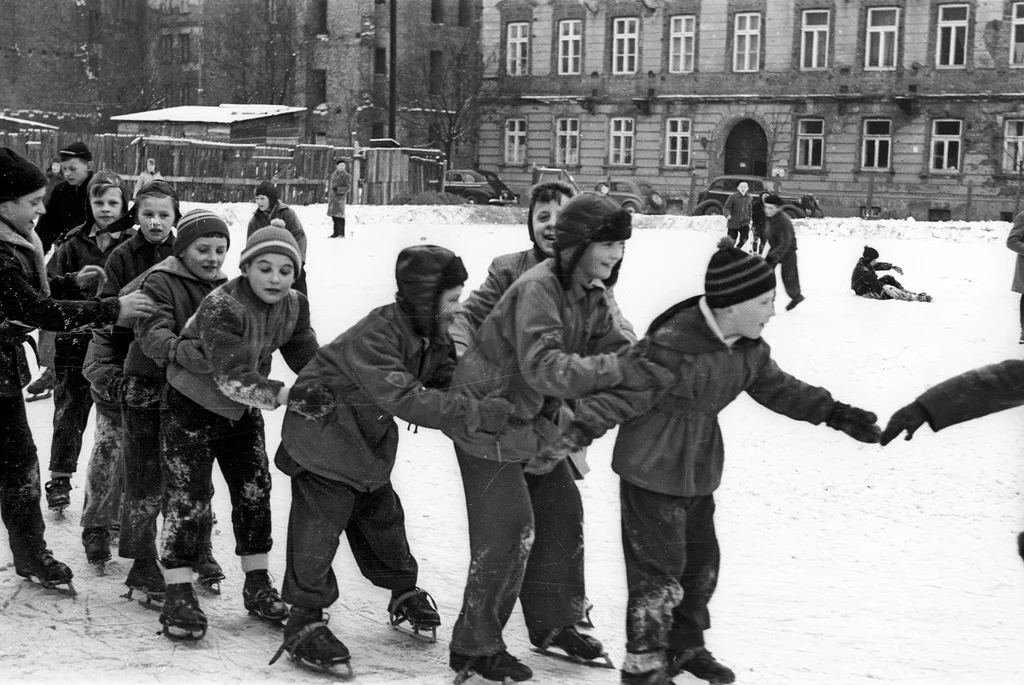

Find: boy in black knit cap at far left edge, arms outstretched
<box><xmin>0</xmin><ymin>147</ymin><xmax>153</xmax><ymax>587</ymax></box>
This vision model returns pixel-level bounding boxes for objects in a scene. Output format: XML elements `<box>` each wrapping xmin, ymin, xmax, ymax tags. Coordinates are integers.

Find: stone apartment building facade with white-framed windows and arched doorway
<box><xmin>478</xmin><ymin>0</ymin><xmax>1024</xmax><ymax>219</ymax></box>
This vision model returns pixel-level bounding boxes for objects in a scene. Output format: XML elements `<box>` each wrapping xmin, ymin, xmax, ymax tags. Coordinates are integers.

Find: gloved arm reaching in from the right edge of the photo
<box><xmin>882</xmin><ymin>359</ymin><xmax>1024</xmax><ymax>559</ymax></box>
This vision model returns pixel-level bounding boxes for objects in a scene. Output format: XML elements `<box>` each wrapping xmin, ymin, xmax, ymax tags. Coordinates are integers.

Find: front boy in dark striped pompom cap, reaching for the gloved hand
<box><xmin>567</xmin><ymin>238</ymin><xmax>880</xmax><ymax>685</ymax></box>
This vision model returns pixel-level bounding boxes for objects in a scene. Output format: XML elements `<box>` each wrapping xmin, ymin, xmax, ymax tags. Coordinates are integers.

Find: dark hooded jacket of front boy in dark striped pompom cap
<box><xmin>578</xmin><ymin>296</ymin><xmax>835</xmax><ymax>497</ymax></box>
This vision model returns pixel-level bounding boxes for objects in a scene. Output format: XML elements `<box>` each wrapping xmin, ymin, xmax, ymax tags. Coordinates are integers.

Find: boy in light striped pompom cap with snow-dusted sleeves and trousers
<box><xmin>160</xmin><ymin>226</ymin><xmax>324</xmax><ymax>639</ymax></box>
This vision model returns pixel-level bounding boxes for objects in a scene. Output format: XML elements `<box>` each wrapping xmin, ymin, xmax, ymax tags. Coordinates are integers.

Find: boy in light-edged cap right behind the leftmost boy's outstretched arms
<box><xmin>45</xmin><ymin>171</ymin><xmax>133</xmax><ymax>512</ymax></box>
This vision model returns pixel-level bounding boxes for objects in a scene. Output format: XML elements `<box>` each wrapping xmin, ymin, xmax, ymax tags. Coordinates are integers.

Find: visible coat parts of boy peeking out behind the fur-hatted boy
<box><xmin>450</xmin><ymin>248</ymin><xmax>636</xmax><ymax>355</ymax></box>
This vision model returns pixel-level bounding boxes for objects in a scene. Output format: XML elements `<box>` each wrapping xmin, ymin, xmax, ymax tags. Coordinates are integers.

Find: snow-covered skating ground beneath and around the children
<box><xmin>0</xmin><ymin>205</ymin><xmax>1024</xmax><ymax>685</ymax></box>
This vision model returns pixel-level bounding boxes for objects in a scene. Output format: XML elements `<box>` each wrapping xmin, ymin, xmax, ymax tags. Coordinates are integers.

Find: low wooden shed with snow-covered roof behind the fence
<box><xmin>111</xmin><ymin>104</ymin><xmax>306</xmax><ymax>146</ymax></box>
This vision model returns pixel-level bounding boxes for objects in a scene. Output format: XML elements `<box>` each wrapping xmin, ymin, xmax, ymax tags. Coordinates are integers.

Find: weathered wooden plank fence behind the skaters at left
<box><xmin>0</xmin><ymin>130</ymin><xmax>443</xmax><ymax>205</ymax></box>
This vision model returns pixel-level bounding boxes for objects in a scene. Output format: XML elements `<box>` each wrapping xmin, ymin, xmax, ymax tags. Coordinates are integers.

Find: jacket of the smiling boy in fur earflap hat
<box><xmin>450</xmin><ymin>259</ymin><xmax>631</xmax><ymax>462</ymax></box>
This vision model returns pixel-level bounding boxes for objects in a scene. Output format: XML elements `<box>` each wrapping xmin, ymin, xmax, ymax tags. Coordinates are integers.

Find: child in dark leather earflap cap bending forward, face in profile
<box><xmin>274</xmin><ymin>245</ymin><xmax>511</xmax><ymax>666</ymax></box>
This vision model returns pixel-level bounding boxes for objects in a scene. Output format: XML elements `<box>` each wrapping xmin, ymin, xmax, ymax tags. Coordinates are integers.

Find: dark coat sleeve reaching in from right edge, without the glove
<box><xmin>918</xmin><ymin>359</ymin><xmax>1024</xmax><ymax>431</ymax></box>
